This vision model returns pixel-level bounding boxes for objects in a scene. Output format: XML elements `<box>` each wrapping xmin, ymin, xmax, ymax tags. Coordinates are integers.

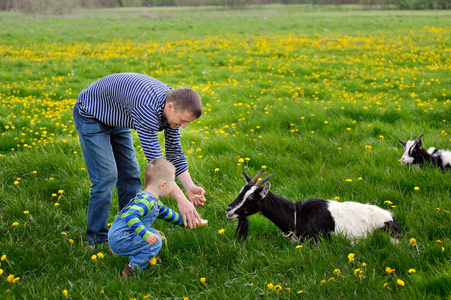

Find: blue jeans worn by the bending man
<box><xmin>73</xmin><ymin>104</ymin><xmax>142</xmax><ymax>245</ymax></box>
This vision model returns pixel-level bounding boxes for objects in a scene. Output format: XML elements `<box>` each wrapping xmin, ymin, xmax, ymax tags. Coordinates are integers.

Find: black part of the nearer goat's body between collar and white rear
<box><xmin>296</xmin><ymin>198</ymin><xmax>335</xmax><ymax>240</ymax></box>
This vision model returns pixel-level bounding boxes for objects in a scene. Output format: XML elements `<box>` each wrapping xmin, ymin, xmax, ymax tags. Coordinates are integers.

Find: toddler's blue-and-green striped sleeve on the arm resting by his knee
<box><xmin>121</xmin><ymin>197</ymin><xmax>153</xmax><ymax>241</ymax></box>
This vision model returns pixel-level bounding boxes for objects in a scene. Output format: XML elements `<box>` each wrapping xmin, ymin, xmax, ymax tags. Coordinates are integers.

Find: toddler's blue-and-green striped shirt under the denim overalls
<box><xmin>120</xmin><ymin>191</ymin><xmax>184</xmax><ymax>241</ymax></box>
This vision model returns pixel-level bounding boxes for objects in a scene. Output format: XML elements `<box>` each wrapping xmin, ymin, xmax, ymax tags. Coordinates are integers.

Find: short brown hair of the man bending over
<box><xmin>166</xmin><ymin>87</ymin><xmax>202</xmax><ymax>119</ymax></box>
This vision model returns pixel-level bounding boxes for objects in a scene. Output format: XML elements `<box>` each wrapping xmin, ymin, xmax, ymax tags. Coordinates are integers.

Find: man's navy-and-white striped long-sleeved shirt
<box><xmin>77</xmin><ymin>73</ymin><xmax>188</xmax><ymax>176</ymax></box>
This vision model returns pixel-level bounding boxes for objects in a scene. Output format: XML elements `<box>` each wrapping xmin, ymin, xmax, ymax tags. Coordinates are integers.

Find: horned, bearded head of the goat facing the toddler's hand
<box><xmin>227</xmin><ymin>170</ymin><xmax>274</xmax><ymax>241</ymax></box>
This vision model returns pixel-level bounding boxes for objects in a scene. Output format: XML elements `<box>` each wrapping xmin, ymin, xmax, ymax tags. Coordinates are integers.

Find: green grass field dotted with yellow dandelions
<box><xmin>0</xmin><ymin>6</ymin><xmax>451</xmax><ymax>299</ymax></box>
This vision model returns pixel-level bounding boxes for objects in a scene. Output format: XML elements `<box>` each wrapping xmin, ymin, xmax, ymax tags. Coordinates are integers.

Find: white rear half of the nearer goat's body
<box><xmin>328</xmin><ymin>200</ymin><xmax>393</xmax><ymax>238</ymax></box>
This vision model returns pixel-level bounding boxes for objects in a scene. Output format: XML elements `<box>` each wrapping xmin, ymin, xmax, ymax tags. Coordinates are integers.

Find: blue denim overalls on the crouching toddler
<box><xmin>108</xmin><ymin>199</ymin><xmax>162</xmax><ymax>270</ymax></box>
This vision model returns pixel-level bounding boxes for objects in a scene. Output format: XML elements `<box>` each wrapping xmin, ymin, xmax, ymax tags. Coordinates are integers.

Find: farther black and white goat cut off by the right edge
<box><xmin>398</xmin><ymin>133</ymin><xmax>451</xmax><ymax>170</ymax></box>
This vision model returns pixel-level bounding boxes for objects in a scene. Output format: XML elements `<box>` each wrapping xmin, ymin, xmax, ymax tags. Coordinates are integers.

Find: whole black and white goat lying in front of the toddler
<box><xmin>227</xmin><ymin>170</ymin><xmax>401</xmax><ymax>241</ymax></box>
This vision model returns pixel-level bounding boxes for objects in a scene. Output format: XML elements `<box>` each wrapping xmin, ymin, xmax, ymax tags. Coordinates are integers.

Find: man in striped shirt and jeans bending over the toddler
<box><xmin>74</xmin><ymin>73</ymin><xmax>206</xmax><ymax>246</ymax></box>
